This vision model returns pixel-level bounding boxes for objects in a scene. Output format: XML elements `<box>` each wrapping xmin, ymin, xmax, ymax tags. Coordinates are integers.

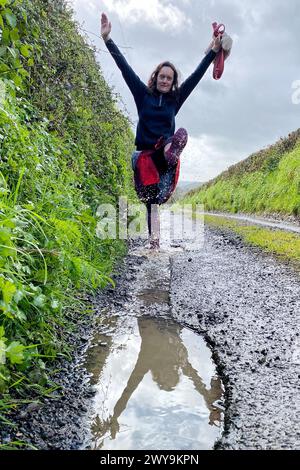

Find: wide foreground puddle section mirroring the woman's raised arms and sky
<box><xmin>86</xmin><ymin>317</ymin><xmax>223</xmax><ymax>450</ymax></box>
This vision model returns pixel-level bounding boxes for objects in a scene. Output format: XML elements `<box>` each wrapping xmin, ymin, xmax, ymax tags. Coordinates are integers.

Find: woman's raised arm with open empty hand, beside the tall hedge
<box><xmin>101</xmin><ymin>13</ymin><xmax>147</xmax><ymax>109</ymax></box>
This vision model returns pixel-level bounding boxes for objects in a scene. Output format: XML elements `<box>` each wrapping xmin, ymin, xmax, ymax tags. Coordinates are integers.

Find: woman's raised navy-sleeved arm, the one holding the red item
<box><xmin>177</xmin><ymin>36</ymin><xmax>221</xmax><ymax>112</ymax></box>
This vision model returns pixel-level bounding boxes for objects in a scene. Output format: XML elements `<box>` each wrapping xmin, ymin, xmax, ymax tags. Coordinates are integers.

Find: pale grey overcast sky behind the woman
<box><xmin>69</xmin><ymin>0</ymin><xmax>300</xmax><ymax>181</ymax></box>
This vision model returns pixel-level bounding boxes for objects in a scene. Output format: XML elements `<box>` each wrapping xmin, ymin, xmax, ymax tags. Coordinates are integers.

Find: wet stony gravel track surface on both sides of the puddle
<box><xmin>2</xmin><ymin>218</ymin><xmax>300</xmax><ymax>449</ymax></box>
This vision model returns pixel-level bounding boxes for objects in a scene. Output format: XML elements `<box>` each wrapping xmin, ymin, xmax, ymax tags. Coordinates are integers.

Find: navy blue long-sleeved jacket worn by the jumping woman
<box><xmin>106</xmin><ymin>39</ymin><xmax>216</xmax><ymax>150</ymax></box>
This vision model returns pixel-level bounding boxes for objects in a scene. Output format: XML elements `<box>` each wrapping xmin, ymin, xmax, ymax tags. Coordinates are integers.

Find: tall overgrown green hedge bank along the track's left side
<box><xmin>0</xmin><ymin>0</ymin><xmax>135</xmax><ymax>421</ymax></box>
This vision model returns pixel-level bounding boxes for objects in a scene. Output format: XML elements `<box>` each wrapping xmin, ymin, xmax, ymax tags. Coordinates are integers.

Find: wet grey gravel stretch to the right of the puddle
<box><xmin>171</xmin><ymin>229</ymin><xmax>300</xmax><ymax>449</ymax></box>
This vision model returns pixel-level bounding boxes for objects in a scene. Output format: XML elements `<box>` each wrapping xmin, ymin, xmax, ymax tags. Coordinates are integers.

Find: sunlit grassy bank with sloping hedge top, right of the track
<box><xmin>185</xmin><ymin>129</ymin><xmax>300</xmax><ymax>216</ymax></box>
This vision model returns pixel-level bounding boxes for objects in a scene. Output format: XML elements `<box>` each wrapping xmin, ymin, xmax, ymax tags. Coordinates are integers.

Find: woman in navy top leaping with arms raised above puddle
<box><xmin>101</xmin><ymin>13</ymin><xmax>226</xmax><ymax>248</ymax></box>
